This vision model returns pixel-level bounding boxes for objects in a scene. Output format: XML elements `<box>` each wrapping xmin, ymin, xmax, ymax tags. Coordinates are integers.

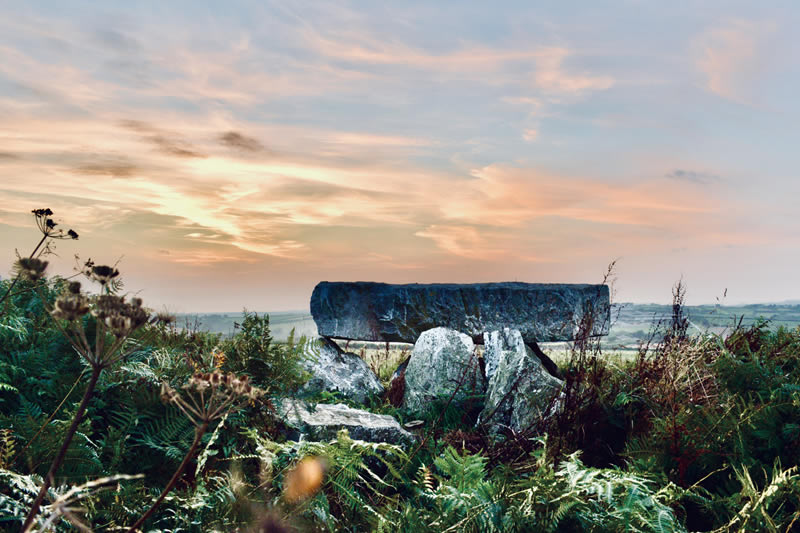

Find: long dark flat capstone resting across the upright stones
<box><xmin>311</xmin><ymin>281</ymin><xmax>610</xmax><ymax>343</ymax></box>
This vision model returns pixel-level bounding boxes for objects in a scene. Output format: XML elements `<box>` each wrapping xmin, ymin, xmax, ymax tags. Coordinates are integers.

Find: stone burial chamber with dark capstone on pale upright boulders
<box><xmin>305</xmin><ymin>281</ymin><xmax>610</xmax><ymax>434</ymax></box>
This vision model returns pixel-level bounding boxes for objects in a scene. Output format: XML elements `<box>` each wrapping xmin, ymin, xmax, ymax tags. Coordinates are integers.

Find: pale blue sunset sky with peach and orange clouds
<box><xmin>0</xmin><ymin>0</ymin><xmax>800</xmax><ymax>312</ymax></box>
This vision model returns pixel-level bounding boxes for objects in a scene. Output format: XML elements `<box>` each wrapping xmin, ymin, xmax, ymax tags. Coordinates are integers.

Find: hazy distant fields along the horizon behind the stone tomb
<box><xmin>178</xmin><ymin>304</ymin><xmax>800</xmax><ymax>352</ymax></box>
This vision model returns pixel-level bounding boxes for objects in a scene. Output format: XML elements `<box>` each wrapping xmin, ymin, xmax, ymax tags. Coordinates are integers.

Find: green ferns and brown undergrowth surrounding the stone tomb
<box><xmin>0</xmin><ymin>210</ymin><xmax>800</xmax><ymax>533</ymax></box>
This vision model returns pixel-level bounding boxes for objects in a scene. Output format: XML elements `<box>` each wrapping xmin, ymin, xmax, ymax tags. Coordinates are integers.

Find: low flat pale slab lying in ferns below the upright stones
<box><xmin>278</xmin><ymin>399</ymin><xmax>416</xmax><ymax>446</ymax></box>
